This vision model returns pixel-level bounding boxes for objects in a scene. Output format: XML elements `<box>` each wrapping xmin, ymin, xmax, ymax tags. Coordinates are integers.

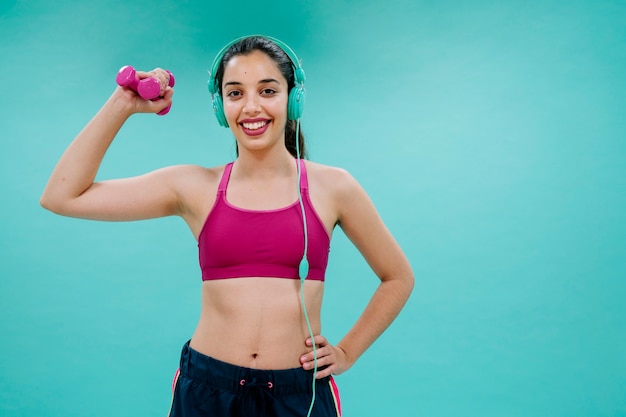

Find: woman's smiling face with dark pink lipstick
<box><xmin>222</xmin><ymin>51</ymin><xmax>289</xmax><ymax>152</ymax></box>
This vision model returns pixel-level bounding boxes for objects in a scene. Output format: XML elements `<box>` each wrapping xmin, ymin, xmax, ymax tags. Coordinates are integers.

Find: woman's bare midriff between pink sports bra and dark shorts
<box><xmin>190</xmin><ymin>277</ymin><xmax>324</xmax><ymax>369</ymax></box>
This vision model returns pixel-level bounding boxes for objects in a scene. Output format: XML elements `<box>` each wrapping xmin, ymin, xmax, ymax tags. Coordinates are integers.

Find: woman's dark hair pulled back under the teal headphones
<box><xmin>215</xmin><ymin>36</ymin><xmax>307</xmax><ymax>158</ymax></box>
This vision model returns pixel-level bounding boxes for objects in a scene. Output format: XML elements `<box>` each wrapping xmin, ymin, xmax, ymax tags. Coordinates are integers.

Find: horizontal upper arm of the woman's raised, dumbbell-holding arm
<box><xmin>59</xmin><ymin>167</ymin><xmax>180</xmax><ymax>221</ymax></box>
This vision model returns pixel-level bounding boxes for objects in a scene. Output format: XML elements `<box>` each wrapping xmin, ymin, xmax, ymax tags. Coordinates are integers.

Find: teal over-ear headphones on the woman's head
<box><xmin>209</xmin><ymin>35</ymin><xmax>306</xmax><ymax>127</ymax></box>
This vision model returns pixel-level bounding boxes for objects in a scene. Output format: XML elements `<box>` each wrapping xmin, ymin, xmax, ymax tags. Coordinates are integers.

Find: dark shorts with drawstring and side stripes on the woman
<box><xmin>169</xmin><ymin>342</ymin><xmax>341</xmax><ymax>417</ymax></box>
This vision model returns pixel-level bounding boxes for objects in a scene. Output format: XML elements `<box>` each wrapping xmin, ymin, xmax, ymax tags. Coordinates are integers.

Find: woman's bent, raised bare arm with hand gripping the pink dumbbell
<box><xmin>40</xmin><ymin>69</ymin><xmax>178</xmax><ymax>220</ymax></box>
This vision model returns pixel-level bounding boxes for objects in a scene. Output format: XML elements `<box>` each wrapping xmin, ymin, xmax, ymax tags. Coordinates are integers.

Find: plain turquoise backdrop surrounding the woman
<box><xmin>0</xmin><ymin>0</ymin><xmax>626</xmax><ymax>417</ymax></box>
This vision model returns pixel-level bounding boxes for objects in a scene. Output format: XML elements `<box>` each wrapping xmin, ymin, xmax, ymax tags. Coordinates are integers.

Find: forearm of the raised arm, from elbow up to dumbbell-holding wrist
<box><xmin>41</xmin><ymin>91</ymin><xmax>131</xmax><ymax>212</ymax></box>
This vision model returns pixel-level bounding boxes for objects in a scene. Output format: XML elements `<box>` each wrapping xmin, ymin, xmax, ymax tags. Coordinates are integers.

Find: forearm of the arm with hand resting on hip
<box><xmin>337</xmin><ymin>274</ymin><xmax>413</xmax><ymax>366</ymax></box>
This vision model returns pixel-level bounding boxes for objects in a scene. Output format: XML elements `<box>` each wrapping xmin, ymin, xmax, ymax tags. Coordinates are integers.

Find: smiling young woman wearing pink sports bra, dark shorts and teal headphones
<box><xmin>41</xmin><ymin>36</ymin><xmax>413</xmax><ymax>417</ymax></box>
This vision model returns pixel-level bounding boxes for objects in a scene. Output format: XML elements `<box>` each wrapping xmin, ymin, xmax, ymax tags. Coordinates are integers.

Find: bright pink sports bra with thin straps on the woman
<box><xmin>198</xmin><ymin>160</ymin><xmax>330</xmax><ymax>281</ymax></box>
